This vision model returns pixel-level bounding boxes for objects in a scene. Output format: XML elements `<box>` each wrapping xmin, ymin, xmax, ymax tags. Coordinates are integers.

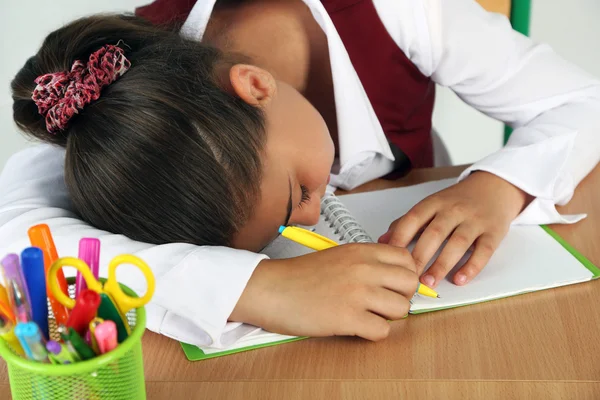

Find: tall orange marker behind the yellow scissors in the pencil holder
<box><xmin>27</xmin><ymin>224</ymin><xmax>69</xmax><ymax>325</ymax></box>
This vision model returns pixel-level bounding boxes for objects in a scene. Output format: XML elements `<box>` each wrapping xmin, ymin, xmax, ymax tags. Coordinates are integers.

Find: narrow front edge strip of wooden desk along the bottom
<box><xmin>147</xmin><ymin>381</ymin><xmax>600</xmax><ymax>400</ymax></box>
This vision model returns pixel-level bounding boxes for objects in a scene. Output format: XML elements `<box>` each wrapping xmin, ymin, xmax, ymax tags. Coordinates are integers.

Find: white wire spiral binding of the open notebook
<box><xmin>321</xmin><ymin>193</ymin><xmax>373</xmax><ymax>243</ymax></box>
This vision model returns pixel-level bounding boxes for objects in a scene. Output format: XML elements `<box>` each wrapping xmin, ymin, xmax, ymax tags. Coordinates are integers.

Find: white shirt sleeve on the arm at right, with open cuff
<box><xmin>375</xmin><ymin>0</ymin><xmax>600</xmax><ymax>224</ymax></box>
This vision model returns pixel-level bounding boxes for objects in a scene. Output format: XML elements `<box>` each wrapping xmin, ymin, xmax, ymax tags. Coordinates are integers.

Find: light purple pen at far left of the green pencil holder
<box><xmin>0</xmin><ymin>254</ymin><xmax>31</xmax><ymax>322</ymax></box>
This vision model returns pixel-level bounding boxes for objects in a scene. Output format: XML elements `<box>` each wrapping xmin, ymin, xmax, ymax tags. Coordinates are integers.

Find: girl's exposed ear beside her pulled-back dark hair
<box><xmin>229</xmin><ymin>64</ymin><xmax>277</xmax><ymax>106</ymax></box>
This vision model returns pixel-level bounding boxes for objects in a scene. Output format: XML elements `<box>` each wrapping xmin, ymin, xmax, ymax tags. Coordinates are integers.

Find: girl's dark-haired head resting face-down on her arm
<box><xmin>12</xmin><ymin>16</ymin><xmax>333</xmax><ymax>250</ymax></box>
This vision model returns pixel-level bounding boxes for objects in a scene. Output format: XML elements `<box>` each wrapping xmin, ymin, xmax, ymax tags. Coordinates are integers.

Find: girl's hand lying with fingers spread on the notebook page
<box><xmin>379</xmin><ymin>172</ymin><xmax>529</xmax><ymax>287</ymax></box>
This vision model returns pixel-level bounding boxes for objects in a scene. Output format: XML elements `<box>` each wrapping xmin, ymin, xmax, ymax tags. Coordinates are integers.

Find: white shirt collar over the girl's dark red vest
<box><xmin>181</xmin><ymin>0</ymin><xmax>394</xmax><ymax>174</ymax></box>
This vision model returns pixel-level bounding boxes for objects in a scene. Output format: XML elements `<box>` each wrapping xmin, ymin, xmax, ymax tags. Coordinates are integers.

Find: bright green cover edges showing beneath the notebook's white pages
<box><xmin>181</xmin><ymin>225</ymin><xmax>600</xmax><ymax>361</ymax></box>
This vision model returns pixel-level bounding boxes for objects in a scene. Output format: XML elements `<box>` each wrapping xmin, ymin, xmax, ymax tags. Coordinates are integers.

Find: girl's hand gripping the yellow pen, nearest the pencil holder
<box><xmin>230</xmin><ymin>244</ymin><xmax>418</xmax><ymax>340</ymax></box>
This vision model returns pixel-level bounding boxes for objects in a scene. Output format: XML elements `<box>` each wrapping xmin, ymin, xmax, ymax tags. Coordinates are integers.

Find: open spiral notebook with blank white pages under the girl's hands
<box><xmin>182</xmin><ymin>179</ymin><xmax>600</xmax><ymax>360</ymax></box>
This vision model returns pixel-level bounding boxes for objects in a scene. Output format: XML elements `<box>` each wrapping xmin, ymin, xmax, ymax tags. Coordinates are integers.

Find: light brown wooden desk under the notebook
<box><xmin>136</xmin><ymin>167</ymin><xmax>600</xmax><ymax>400</ymax></box>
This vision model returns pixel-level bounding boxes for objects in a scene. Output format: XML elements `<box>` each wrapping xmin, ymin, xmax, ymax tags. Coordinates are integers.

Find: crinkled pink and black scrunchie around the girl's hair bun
<box><xmin>31</xmin><ymin>44</ymin><xmax>131</xmax><ymax>134</ymax></box>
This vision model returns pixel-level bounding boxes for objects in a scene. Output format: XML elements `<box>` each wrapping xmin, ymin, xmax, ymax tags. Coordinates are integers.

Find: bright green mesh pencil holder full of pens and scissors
<box><xmin>0</xmin><ymin>279</ymin><xmax>146</xmax><ymax>400</ymax></box>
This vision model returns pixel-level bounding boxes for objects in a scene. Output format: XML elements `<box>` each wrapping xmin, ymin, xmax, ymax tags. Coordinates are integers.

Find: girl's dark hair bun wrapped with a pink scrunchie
<box><xmin>11</xmin><ymin>15</ymin><xmax>157</xmax><ymax>146</ymax></box>
